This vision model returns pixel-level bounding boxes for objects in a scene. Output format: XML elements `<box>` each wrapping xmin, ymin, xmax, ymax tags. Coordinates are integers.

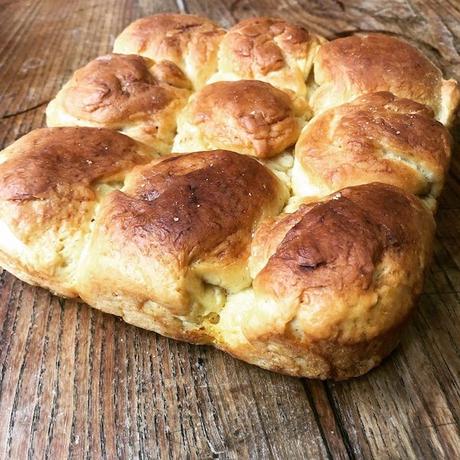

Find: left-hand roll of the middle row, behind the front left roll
<box><xmin>47</xmin><ymin>54</ymin><xmax>190</xmax><ymax>153</ymax></box>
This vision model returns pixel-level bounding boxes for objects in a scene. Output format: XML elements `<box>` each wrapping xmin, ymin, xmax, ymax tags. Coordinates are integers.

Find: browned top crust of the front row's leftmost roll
<box><xmin>0</xmin><ymin>128</ymin><xmax>148</xmax><ymax>201</ymax></box>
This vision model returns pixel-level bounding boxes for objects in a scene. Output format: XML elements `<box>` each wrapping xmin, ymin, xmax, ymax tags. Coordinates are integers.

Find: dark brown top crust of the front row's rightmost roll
<box><xmin>254</xmin><ymin>184</ymin><xmax>431</xmax><ymax>297</ymax></box>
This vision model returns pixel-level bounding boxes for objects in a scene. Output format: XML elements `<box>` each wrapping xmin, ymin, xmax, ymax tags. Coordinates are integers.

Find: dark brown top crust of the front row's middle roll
<box><xmin>113</xmin><ymin>150</ymin><xmax>280</xmax><ymax>255</ymax></box>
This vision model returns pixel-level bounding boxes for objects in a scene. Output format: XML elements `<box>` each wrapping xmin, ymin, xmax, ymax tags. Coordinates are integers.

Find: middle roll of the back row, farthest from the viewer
<box><xmin>213</xmin><ymin>17</ymin><xmax>324</xmax><ymax>110</ymax></box>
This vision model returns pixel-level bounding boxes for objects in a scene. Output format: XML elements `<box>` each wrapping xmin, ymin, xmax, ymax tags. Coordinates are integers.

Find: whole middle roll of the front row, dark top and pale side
<box><xmin>79</xmin><ymin>151</ymin><xmax>288</xmax><ymax>341</ymax></box>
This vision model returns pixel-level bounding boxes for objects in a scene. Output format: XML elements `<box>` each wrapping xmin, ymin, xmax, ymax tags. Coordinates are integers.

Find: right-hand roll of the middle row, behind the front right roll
<box><xmin>293</xmin><ymin>92</ymin><xmax>451</xmax><ymax>205</ymax></box>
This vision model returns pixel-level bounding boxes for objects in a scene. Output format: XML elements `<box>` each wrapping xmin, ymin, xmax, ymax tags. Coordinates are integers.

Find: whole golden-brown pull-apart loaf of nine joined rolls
<box><xmin>0</xmin><ymin>13</ymin><xmax>460</xmax><ymax>379</ymax></box>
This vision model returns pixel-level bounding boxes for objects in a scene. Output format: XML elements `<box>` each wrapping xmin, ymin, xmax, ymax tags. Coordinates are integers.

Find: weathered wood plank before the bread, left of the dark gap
<box><xmin>0</xmin><ymin>272</ymin><xmax>327</xmax><ymax>458</ymax></box>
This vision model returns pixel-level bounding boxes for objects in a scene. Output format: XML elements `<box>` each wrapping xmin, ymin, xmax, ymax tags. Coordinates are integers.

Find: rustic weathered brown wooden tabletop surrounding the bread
<box><xmin>0</xmin><ymin>0</ymin><xmax>460</xmax><ymax>459</ymax></box>
